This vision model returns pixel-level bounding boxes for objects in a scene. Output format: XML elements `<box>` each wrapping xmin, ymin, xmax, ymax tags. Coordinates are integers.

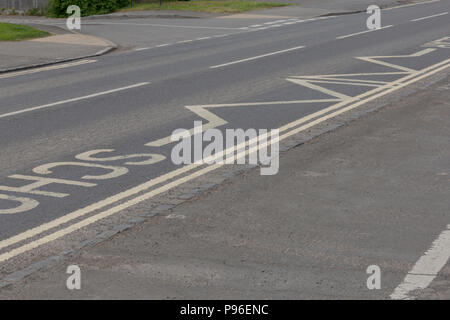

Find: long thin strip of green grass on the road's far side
<box><xmin>120</xmin><ymin>0</ymin><xmax>289</xmax><ymax>13</ymax></box>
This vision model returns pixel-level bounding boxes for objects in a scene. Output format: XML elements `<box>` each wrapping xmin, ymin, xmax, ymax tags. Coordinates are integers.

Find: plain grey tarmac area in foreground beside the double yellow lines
<box><xmin>0</xmin><ymin>69</ymin><xmax>450</xmax><ymax>299</ymax></box>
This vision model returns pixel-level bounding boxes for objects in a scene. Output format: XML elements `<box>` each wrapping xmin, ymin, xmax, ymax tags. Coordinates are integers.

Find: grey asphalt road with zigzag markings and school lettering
<box><xmin>0</xmin><ymin>0</ymin><xmax>450</xmax><ymax>298</ymax></box>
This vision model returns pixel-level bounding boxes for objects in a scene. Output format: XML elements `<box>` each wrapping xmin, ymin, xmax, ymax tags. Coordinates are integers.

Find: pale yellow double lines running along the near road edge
<box><xmin>0</xmin><ymin>55</ymin><xmax>450</xmax><ymax>262</ymax></box>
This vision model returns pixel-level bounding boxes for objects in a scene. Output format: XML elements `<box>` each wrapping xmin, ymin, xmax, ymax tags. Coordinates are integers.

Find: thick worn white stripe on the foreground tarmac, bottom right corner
<box><xmin>390</xmin><ymin>225</ymin><xmax>450</xmax><ymax>300</ymax></box>
